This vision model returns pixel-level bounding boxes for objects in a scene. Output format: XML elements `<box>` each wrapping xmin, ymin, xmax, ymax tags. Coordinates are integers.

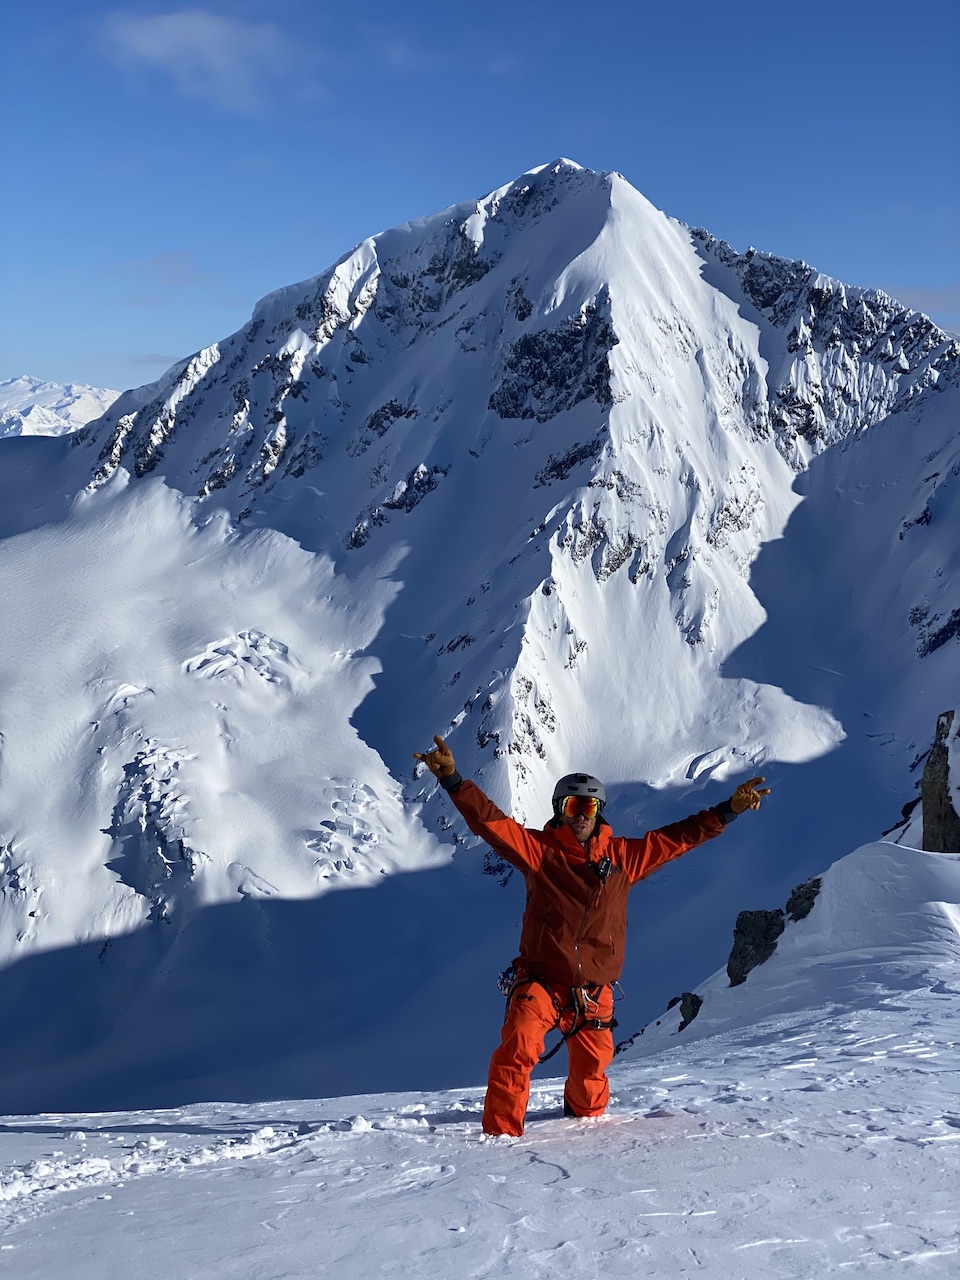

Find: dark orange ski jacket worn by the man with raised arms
<box><xmin>444</xmin><ymin>780</ymin><xmax>733</xmax><ymax>987</ymax></box>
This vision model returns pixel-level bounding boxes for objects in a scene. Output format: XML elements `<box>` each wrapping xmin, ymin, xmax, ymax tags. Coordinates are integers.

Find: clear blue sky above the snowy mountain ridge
<box><xmin>0</xmin><ymin>0</ymin><xmax>960</xmax><ymax>388</ymax></box>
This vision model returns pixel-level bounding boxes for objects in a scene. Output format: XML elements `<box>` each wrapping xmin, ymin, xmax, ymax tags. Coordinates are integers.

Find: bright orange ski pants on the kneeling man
<box><xmin>483</xmin><ymin>982</ymin><xmax>613</xmax><ymax>1137</ymax></box>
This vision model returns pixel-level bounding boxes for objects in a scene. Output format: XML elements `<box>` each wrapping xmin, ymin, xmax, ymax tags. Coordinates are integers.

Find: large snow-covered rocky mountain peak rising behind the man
<box><xmin>0</xmin><ymin>154</ymin><xmax>960</xmax><ymax>1107</ymax></box>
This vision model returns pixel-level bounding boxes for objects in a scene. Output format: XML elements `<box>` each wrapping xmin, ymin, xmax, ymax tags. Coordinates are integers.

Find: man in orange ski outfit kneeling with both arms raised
<box><xmin>413</xmin><ymin>736</ymin><xmax>769</xmax><ymax>1137</ymax></box>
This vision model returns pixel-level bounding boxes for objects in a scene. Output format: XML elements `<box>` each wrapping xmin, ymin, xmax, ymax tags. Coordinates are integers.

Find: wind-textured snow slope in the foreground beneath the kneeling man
<box><xmin>0</xmin><ymin>844</ymin><xmax>960</xmax><ymax>1280</ymax></box>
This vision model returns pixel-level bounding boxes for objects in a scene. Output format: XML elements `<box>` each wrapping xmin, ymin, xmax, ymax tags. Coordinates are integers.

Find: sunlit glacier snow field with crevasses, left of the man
<box><xmin>0</xmin><ymin>471</ymin><xmax>444</xmax><ymax>959</ymax></box>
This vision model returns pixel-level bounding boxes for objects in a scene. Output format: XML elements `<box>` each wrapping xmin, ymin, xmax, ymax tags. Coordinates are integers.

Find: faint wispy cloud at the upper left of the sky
<box><xmin>100</xmin><ymin>9</ymin><xmax>303</xmax><ymax>113</ymax></box>
